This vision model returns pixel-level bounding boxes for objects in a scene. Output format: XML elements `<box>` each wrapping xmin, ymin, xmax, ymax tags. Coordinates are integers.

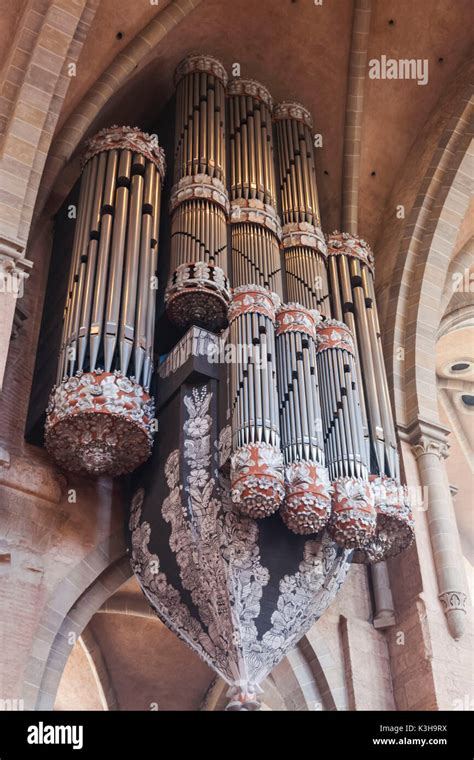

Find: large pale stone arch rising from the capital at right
<box><xmin>382</xmin><ymin>69</ymin><xmax>473</xmax><ymax>425</ymax></box>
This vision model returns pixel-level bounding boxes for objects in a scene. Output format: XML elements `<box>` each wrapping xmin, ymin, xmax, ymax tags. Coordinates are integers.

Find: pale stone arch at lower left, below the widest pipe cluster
<box><xmin>23</xmin><ymin>534</ymin><xmax>132</xmax><ymax>710</ymax></box>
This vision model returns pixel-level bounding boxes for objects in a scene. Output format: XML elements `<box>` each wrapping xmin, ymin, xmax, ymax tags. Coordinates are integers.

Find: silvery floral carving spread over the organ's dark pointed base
<box><xmin>130</xmin><ymin>387</ymin><xmax>349</xmax><ymax>702</ymax></box>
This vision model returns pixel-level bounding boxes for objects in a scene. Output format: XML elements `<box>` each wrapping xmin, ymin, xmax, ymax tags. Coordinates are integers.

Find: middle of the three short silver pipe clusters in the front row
<box><xmin>276</xmin><ymin>304</ymin><xmax>331</xmax><ymax>534</ymax></box>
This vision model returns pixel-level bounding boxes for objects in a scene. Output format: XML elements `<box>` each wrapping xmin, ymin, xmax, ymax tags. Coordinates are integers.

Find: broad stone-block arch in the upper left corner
<box><xmin>0</xmin><ymin>0</ymin><xmax>99</xmax><ymax>248</ymax></box>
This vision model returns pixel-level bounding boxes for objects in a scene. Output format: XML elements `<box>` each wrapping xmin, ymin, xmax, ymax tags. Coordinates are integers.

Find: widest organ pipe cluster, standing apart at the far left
<box><xmin>45</xmin><ymin>127</ymin><xmax>165</xmax><ymax>474</ymax></box>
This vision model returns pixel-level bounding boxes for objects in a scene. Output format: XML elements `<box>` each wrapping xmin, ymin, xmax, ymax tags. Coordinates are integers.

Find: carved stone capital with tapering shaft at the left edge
<box><xmin>0</xmin><ymin>237</ymin><xmax>33</xmax><ymax>390</ymax></box>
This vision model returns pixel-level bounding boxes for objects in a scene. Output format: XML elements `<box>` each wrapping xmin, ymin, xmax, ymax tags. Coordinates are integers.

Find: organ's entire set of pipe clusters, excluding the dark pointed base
<box><xmin>46</xmin><ymin>55</ymin><xmax>413</xmax><ymax>562</ymax></box>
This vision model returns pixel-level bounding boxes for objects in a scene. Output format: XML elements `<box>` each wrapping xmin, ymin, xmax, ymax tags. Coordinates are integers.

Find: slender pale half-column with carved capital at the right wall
<box><xmin>409</xmin><ymin>420</ymin><xmax>467</xmax><ymax>641</ymax></box>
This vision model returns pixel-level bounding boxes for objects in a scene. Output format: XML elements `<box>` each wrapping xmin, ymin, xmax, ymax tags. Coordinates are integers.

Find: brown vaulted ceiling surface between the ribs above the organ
<box><xmin>39</xmin><ymin>0</ymin><xmax>472</xmax><ymax>245</ymax></box>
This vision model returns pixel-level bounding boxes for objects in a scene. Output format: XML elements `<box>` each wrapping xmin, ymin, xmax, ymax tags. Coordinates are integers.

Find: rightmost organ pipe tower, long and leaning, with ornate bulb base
<box><xmin>327</xmin><ymin>232</ymin><xmax>414</xmax><ymax>562</ymax></box>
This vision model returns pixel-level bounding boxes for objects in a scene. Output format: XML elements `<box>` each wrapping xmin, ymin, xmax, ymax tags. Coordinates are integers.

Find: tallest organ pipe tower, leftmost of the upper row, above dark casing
<box><xmin>166</xmin><ymin>55</ymin><xmax>230</xmax><ymax>330</ymax></box>
